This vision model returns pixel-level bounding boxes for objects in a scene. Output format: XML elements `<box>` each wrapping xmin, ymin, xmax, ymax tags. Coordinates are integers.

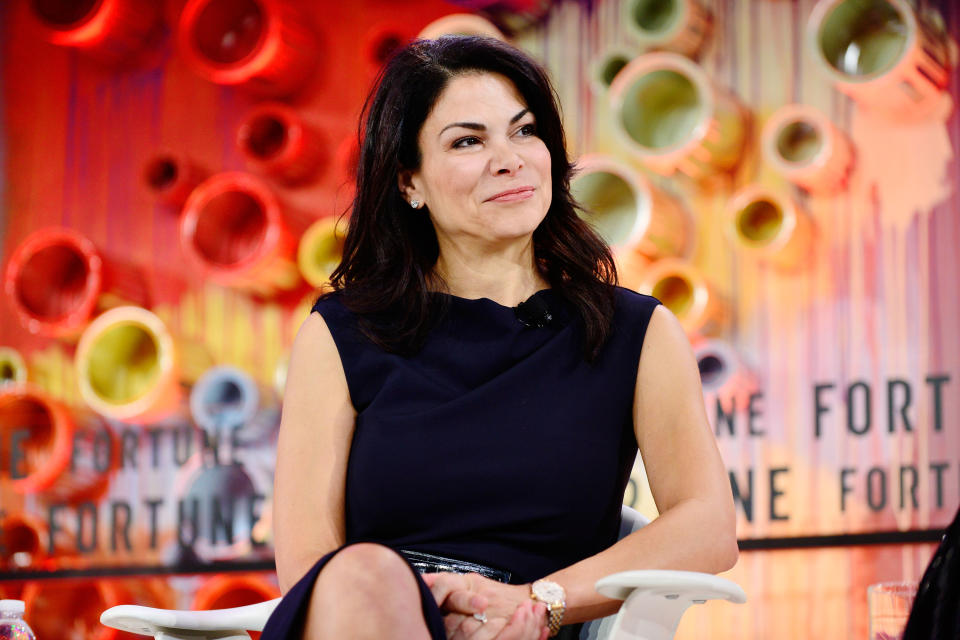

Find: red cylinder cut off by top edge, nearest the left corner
<box><xmin>30</xmin><ymin>0</ymin><xmax>161</xmax><ymax>64</ymax></box>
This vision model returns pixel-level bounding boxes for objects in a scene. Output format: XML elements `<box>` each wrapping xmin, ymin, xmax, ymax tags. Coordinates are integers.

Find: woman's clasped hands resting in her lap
<box><xmin>423</xmin><ymin>573</ymin><xmax>549</xmax><ymax>640</ymax></box>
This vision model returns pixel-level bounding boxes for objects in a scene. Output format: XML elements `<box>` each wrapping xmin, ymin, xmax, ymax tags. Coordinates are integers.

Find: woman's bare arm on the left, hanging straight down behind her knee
<box><xmin>273</xmin><ymin>313</ymin><xmax>356</xmax><ymax>593</ymax></box>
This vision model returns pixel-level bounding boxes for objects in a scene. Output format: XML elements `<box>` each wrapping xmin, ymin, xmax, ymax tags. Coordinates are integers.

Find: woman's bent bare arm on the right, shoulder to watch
<box><xmin>549</xmin><ymin>305</ymin><xmax>738</xmax><ymax>622</ymax></box>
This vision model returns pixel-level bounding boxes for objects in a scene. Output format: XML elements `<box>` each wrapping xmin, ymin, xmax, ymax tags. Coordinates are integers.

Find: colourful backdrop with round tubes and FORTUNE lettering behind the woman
<box><xmin>0</xmin><ymin>0</ymin><xmax>960</xmax><ymax>640</ymax></box>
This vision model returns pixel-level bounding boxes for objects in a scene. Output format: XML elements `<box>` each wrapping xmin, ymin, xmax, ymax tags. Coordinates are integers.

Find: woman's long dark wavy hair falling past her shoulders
<box><xmin>324</xmin><ymin>36</ymin><xmax>617</xmax><ymax>361</ymax></box>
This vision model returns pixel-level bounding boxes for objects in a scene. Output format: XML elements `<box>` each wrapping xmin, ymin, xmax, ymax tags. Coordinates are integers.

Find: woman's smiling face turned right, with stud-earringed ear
<box><xmin>400</xmin><ymin>73</ymin><xmax>553</xmax><ymax>247</ymax></box>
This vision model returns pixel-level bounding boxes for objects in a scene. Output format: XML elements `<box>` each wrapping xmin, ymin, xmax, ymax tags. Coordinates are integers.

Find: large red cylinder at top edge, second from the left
<box><xmin>177</xmin><ymin>0</ymin><xmax>320</xmax><ymax>96</ymax></box>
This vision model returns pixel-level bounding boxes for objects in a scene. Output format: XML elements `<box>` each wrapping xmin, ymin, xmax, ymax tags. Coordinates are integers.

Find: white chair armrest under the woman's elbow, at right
<box><xmin>596</xmin><ymin>570</ymin><xmax>747</xmax><ymax>640</ymax></box>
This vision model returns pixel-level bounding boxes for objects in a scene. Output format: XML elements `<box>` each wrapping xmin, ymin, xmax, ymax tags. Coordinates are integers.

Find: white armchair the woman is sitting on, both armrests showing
<box><xmin>100</xmin><ymin>506</ymin><xmax>747</xmax><ymax>640</ymax></box>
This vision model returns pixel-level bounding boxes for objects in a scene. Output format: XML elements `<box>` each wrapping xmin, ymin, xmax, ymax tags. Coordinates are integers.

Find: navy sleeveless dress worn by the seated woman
<box><xmin>263</xmin><ymin>287</ymin><xmax>659</xmax><ymax>639</ymax></box>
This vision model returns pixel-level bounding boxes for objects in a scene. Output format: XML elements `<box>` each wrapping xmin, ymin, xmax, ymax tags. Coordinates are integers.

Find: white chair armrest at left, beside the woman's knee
<box><xmin>100</xmin><ymin>598</ymin><xmax>280</xmax><ymax>640</ymax></box>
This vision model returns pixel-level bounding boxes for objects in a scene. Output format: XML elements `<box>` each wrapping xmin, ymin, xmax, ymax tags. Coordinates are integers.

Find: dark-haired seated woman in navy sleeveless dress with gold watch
<box><xmin>264</xmin><ymin>37</ymin><xmax>737</xmax><ymax>640</ymax></box>
